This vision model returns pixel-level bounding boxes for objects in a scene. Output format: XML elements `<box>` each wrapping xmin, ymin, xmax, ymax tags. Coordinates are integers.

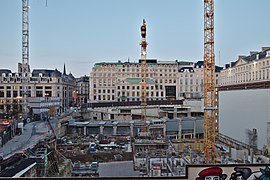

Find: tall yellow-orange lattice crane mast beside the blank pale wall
<box><xmin>204</xmin><ymin>0</ymin><xmax>217</xmax><ymax>164</ymax></box>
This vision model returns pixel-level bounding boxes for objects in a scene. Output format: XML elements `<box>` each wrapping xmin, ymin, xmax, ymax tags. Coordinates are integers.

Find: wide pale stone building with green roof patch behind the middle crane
<box><xmin>89</xmin><ymin>59</ymin><xmax>178</xmax><ymax>102</ymax></box>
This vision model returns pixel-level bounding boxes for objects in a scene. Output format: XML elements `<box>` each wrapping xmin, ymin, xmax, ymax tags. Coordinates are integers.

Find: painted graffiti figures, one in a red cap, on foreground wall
<box><xmin>196</xmin><ymin>165</ymin><xmax>270</xmax><ymax>180</ymax></box>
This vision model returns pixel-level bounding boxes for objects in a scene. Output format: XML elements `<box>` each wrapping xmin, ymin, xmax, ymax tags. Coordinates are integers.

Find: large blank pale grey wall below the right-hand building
<box><xmin>219</xmin><ymin>89</ymin><xmax>270</xmax><ymax>148</ymax></box>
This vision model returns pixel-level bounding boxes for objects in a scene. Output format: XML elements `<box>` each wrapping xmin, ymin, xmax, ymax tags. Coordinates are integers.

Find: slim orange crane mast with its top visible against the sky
<box><xmin>140</xmin><ymin>19</ymin><xmax>147</xmax><ymax>132</ymax></box>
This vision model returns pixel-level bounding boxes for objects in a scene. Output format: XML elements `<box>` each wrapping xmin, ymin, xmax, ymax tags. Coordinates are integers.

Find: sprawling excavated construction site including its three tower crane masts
<box><xmin>0</xmin><ymin>0</ymin><xmax>269</xmax><ymax>179</ymax></box>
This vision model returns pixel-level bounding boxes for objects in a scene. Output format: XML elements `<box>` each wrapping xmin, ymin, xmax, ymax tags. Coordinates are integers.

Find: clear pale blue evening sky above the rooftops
<box><xmin>0</xmin><ymin>0</ymin><xmax>270</xmax><ymax>77</ymax></box>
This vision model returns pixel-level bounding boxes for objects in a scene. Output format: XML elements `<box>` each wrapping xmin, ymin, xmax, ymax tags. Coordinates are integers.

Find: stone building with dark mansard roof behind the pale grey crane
<box><xmin>0</xmin><ymin>64</ymin><xmax>76</xmax><ymax>116</ymax></box>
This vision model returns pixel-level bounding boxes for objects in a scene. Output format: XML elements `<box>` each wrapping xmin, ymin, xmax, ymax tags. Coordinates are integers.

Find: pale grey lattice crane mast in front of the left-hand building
<box><xmin>22</xmin><ymin>0</ymin><xmax>30</xmax><ymax>118</ymax></box>
